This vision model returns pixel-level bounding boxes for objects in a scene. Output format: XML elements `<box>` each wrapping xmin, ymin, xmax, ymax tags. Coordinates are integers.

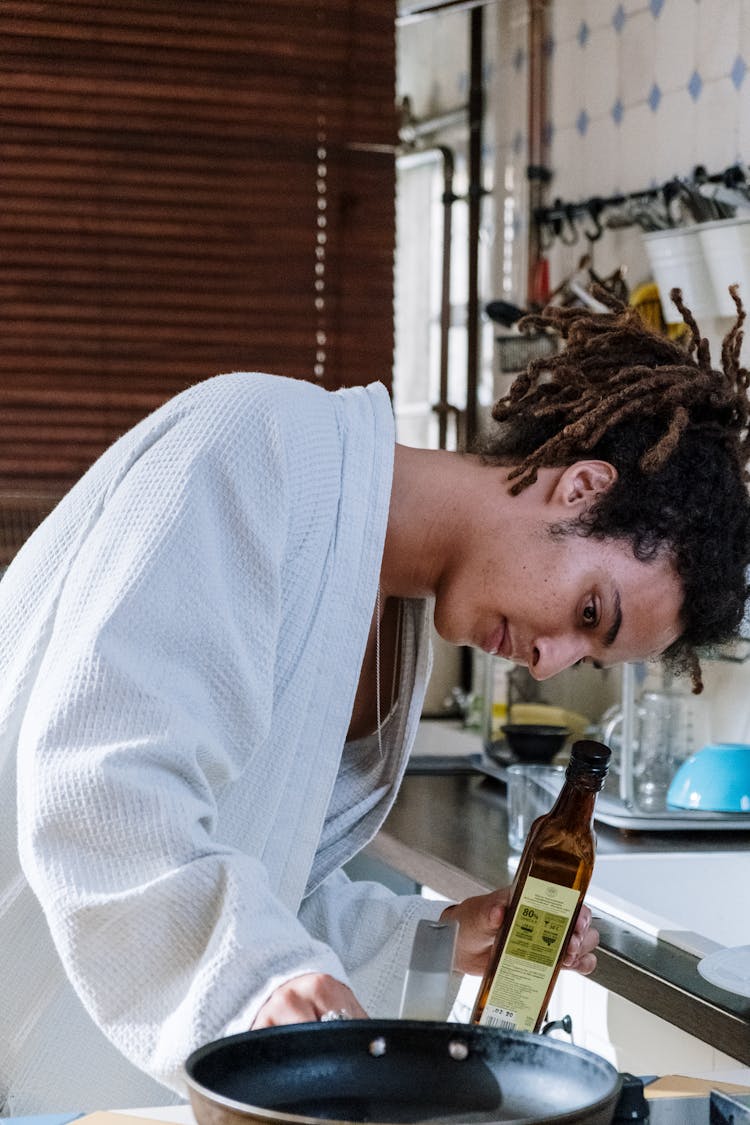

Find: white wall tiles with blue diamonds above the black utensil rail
<box><xmin>550</xmin><ymin>0</ymin><xmax>750</xmax><ymax>196</ymax></box>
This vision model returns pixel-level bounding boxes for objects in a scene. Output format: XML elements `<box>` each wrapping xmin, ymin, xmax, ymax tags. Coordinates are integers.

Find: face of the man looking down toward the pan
<box><xmin>435</xmin><ymin>459</ymin><xmax>683</xmax><ymax>680</ymax></box>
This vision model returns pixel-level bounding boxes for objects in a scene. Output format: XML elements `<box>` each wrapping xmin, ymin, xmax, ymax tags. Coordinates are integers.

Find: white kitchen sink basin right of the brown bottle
<box><xmin>586</xmin><ymin>851</ymin><xmax>750</xmax><ymax>957</ymax></box>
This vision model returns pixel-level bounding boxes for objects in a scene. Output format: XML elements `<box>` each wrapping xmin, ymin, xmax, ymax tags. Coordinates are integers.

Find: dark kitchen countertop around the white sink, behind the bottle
<box><xmin>367</xmin><ymin>723</ymin><xmax>750</xmax><ymax>1065</ymax></box>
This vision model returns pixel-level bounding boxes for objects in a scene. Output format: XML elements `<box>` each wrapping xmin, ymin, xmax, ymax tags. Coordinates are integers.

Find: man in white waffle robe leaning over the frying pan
<box><xmin>0</xmin><ymin>285</ymin><xmax>750</xmax><ymax>1114</ymax></box>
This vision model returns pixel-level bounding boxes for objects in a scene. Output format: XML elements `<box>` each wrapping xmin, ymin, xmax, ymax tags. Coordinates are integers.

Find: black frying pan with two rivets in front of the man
<box><xmin>186</xmin><ymin>1019</ymin><xmax>621</xmax><ymax>1125</ymax></box>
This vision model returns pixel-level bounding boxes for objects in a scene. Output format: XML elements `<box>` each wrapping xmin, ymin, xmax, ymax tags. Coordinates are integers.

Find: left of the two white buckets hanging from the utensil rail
<box><xmin>643</xmin><ymin>226</ymin><xmax>720</xmax><ymax>324</ymax></box>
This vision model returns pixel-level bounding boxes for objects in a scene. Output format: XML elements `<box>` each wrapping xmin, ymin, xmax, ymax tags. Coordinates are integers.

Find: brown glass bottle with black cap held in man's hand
<box><xmin>471</xmin><ymin>739</ymin><xmax>611</xmax><ymax>1032</ymax></box>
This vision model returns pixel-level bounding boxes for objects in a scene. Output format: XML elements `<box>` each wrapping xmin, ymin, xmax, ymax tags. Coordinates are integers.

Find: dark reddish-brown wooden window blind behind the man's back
<box><xmin>0</xmin><ymin>0</ymin><xmax>397</xmax><ymax>563</ymax></box>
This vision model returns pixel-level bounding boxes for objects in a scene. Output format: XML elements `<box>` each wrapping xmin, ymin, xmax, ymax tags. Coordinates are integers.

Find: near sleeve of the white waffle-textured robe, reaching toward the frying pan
<box><xmin>18</xmin><ymin>396</ymin><xmax>347</xmax><ymax>1092</ymax></box>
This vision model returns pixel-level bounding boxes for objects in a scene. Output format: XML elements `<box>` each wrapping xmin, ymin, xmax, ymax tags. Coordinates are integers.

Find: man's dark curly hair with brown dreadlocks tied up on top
<box><xmin>478</xmin><ymin>286</ymin><xmax>750</xmax><ymax>693</ymax></box>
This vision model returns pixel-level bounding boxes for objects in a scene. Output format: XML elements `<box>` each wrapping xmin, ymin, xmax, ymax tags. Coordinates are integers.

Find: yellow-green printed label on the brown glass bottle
<box><xmin>479</xmin><ymin>875</ymin><xmax>579</xmax><ymax>1032</ymax></box>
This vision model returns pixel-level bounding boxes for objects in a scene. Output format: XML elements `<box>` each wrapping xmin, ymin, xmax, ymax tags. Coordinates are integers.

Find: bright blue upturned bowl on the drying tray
<box><xmin>667</xmin><ymin>743</ymin><xmax>750</xmax><ymax>813</ymax></box>
